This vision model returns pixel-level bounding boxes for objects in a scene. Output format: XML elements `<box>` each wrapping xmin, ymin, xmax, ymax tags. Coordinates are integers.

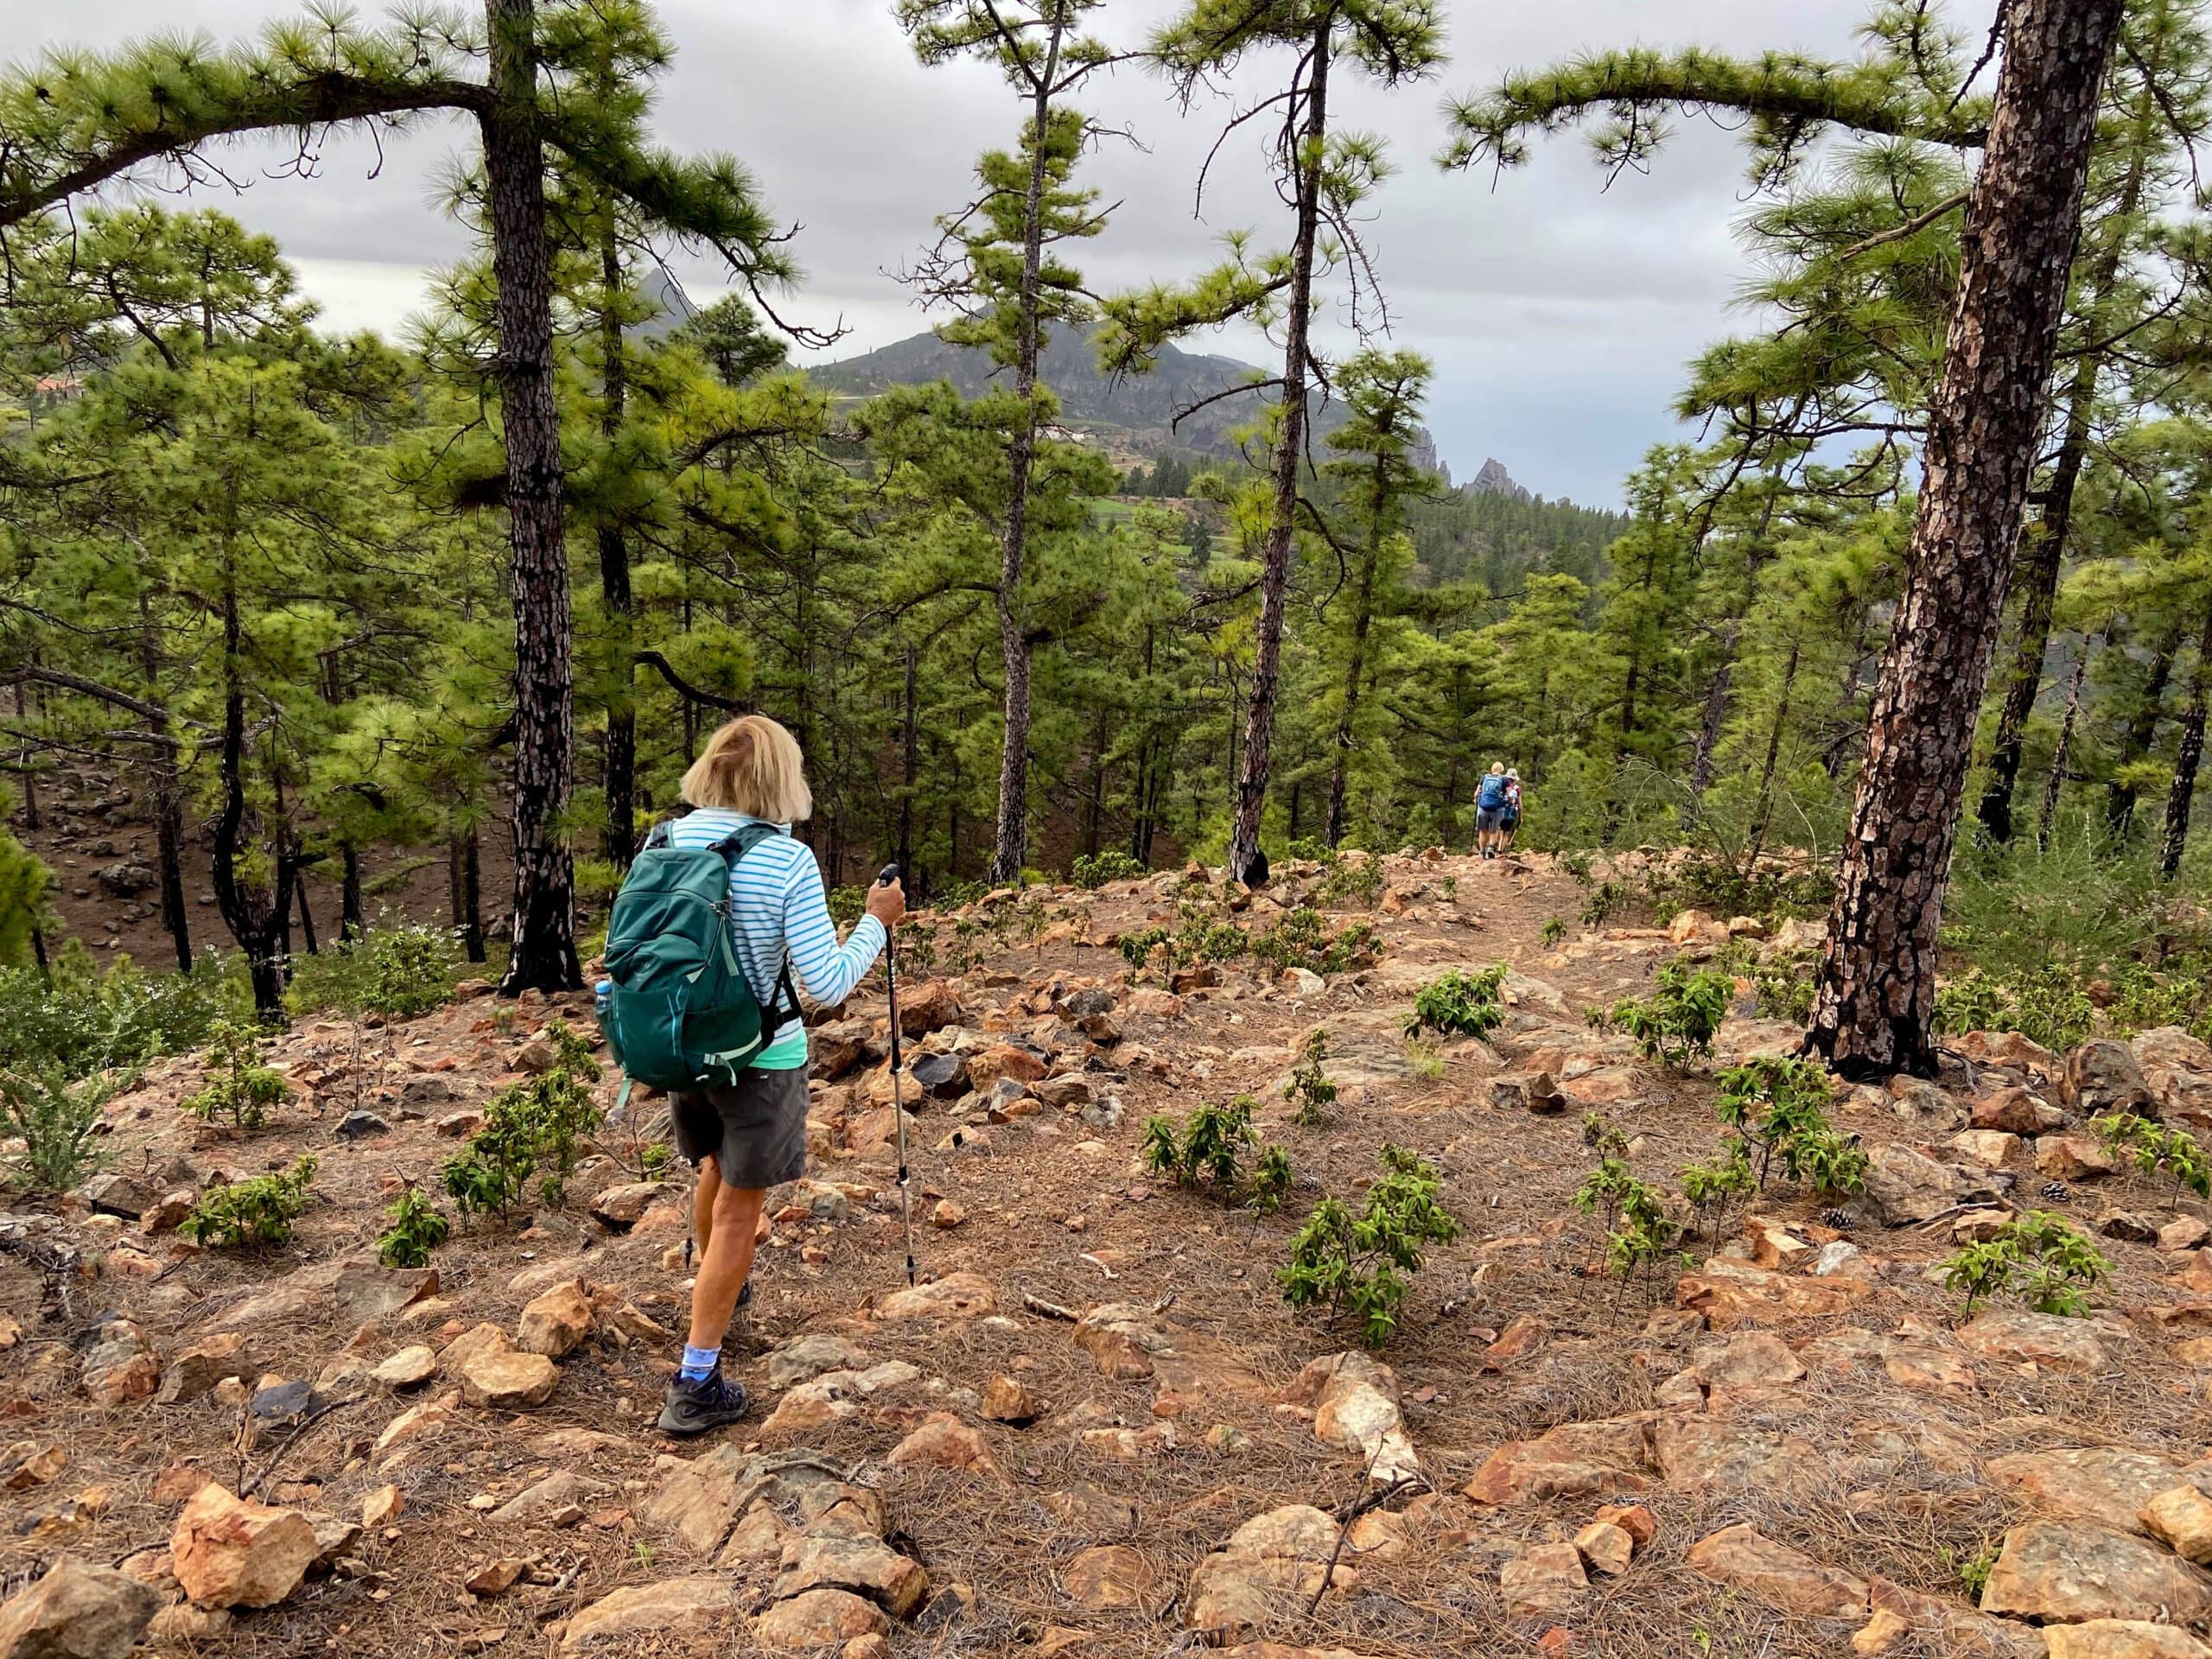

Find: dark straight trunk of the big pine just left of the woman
<box><xmin>480</xmin><ymin>0</ymin><xmax>584</xmax><ymax>995</ymax></box>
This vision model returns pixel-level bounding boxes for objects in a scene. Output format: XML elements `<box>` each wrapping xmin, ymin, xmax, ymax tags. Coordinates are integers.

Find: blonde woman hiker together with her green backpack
<box><xmin>606</xmin><ymin>715</ymin><xmax>907</xmax><ymax>1435</ymax></box>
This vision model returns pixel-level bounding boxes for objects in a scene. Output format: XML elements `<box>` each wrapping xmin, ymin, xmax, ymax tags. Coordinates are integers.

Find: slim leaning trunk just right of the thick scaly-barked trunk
<box><xmin>1978</xmin><ymin>64</ymin><xmax>2159</xmax><ymax>841</ymax></box>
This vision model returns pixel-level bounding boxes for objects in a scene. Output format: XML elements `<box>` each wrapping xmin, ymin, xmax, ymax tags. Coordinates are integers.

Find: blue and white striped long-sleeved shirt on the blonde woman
<box><xmin>668</xmin><ymin>807</ymin><xmax>882</xmax><ymax>1071</ymax></box>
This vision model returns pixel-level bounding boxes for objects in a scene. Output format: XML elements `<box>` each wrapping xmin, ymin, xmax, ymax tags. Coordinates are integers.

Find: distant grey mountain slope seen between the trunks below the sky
<box><xmin>807</xmin><ymin>329</ymin><xmax>1442</xmax><ymax>471</ymax></box>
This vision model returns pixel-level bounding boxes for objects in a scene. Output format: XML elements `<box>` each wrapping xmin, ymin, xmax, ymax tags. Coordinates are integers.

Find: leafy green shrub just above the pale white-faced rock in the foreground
<box><xmin>1281</xmin><ymin>1146</ymin><xmax>1460</xmax><ymax>1347</ymax></box>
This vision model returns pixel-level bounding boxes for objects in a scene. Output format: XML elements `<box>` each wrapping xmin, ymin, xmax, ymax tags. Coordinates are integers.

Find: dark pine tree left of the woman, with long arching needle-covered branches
<box><xmin>0</xmin><ymin>0</ymin><xmax>814</xmax><ymax>993</ymax></box>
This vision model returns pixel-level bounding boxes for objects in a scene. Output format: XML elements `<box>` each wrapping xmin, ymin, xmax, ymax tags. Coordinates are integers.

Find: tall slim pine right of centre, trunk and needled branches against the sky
<box><xmin>1099</xmin><ymin>0</ymin><xmax>1442</xmax><ymax>880</ymax></box>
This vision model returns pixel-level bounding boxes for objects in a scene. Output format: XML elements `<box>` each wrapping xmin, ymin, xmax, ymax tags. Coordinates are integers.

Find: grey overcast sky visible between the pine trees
<box><xmin>7</xmin><ymin>0</ymin><xmax>1988</xmax><ymax>505</ymax></box>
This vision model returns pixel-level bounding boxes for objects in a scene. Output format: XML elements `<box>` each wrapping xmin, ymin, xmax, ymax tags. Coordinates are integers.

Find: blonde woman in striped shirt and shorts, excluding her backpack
<box><xmin>648</xmin><ymin>715</ymin><xmax>907</xmax><ymax>1435</ymax></box>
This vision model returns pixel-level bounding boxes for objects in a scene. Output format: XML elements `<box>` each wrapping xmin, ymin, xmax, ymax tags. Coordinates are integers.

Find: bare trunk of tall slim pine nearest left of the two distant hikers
<box><xmin>1230</xmin><ymin>13</ymin><xmax>1334</xmax><ymax>882</ymax></box>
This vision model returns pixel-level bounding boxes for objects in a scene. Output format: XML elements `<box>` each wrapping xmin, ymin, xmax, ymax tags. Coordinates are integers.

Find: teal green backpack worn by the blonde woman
<box><xmin>600</xmin><ymin>823</ymin><xmax>798</xmax><ymax>1093</ymax></box>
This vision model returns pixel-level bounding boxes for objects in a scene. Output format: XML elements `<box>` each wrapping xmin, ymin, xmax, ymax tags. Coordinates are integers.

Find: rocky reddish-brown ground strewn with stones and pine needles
<box><xmin>0</xmin><ymin>856</ymin><xmax>2212</xmax><ymax>1659</ymax></box>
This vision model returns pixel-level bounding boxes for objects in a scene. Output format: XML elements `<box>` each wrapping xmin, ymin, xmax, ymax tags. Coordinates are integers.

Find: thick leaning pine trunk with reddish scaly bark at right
<box><xmin>1805</xmin><ymin>0</ymin><xmax>2124</xmax><ymax>1075</ymax></box>
